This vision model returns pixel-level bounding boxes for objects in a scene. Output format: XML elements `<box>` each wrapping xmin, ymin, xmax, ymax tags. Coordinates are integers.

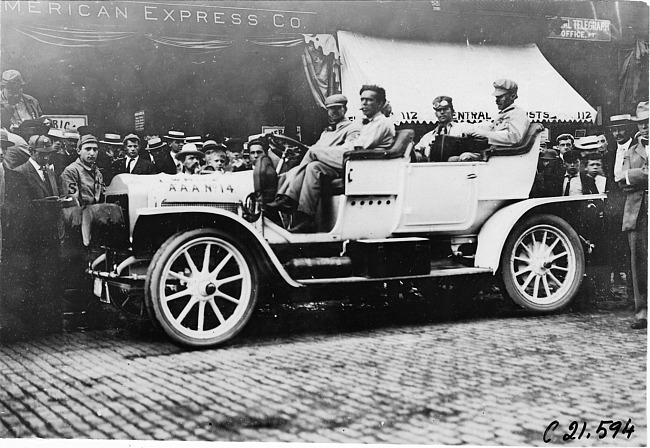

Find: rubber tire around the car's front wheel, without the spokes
<box><xmin>145</xmin><ymin>229</ymin><xmax>260</xmax><ymax>348</ymax></box>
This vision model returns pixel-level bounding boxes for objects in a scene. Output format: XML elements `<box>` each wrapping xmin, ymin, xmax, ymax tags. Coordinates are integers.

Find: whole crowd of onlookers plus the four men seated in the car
<box><xmin>0</xmin><ymin>70</ymin><xmax>648</xmax><ymax>340</ymax></box>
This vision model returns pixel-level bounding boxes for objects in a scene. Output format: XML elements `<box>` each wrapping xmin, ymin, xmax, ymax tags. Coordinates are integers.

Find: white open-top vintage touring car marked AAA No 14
<box><xmin>88</xmin><ymin>124</ymin><xmax>605</xmax><ymax>347</ymax></box>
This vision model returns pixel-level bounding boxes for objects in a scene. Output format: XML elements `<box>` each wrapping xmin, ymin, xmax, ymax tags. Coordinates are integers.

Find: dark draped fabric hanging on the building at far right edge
<box><xmin>618</xmin><ymin>40</ymin><xmax>648</xmax><ymax>115</ymax></box>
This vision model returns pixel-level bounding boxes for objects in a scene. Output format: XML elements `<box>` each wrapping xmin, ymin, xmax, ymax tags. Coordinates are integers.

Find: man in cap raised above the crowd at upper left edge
<box><xmin>0</xmin><ymin>69</ymin><xmax>43</xmax><ymax>131</ymax></box>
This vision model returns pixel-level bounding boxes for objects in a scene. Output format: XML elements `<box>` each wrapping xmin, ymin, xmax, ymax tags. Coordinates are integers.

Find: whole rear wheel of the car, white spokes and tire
<box><xmin>500</xmin><ymin>214</ymin><xmax>585</xmax><ymax>312</ymax></box>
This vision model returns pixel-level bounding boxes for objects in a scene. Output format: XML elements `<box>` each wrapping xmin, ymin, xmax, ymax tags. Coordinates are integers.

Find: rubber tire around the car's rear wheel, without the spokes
<box><xmin>499</xmin><ymin>214</ymin><xmax>585</xmax><ymax>313</ymax></box>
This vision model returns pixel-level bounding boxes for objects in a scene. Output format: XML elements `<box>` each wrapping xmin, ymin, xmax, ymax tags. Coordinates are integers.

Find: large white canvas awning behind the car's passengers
<box><xmin>338</xmin><ymin>31</ymin><xmax>596</xmax><ymax>124</ymax></box>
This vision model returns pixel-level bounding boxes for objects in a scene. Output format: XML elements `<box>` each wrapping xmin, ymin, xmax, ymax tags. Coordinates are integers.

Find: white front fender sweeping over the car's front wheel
<box><xmin>133</xmin><ymin>205</ymin><xmax>304</xmax><ymax>287</ymax></box>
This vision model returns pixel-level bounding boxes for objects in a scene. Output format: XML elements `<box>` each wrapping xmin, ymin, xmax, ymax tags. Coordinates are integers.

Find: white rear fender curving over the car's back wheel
<box><xmin>474</xmin><ymin>194</ymin><xmax>607</xmax><ymax>272</ymax></box>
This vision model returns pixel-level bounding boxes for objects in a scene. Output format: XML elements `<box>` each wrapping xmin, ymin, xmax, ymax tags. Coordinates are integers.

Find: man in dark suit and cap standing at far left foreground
<box><xmin>0</xmin><ymin>135</ymin><xmax>62</xmax><ymax>339</ymax></box>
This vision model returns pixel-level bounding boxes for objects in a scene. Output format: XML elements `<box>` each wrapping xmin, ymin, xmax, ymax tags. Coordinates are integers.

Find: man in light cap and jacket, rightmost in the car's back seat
<box><xmin>460</xmin><ymin>79</ymin><xmax>530</xmax><ymax>161</ymax></box>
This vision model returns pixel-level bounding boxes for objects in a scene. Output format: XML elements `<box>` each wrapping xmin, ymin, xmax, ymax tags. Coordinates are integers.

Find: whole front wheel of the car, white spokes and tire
<box><xmin>145</xmin><ymin>229</ymin><xmax>259</xmax><ymax>347</ymax></box>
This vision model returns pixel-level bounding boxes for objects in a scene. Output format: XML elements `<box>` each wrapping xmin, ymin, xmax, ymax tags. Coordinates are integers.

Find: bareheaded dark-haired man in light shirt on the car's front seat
<box><xmin>269</xmin><ymin>85</ymin><xmax>395</xmax><ymax>233</ymax></box>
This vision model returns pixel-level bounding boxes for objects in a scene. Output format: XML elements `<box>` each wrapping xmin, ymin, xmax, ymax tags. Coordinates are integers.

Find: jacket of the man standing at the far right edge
<box><xmin>619</xmin><ymin>141</ymin><xmax>648</xmax><ymax>232</ymax></box>
